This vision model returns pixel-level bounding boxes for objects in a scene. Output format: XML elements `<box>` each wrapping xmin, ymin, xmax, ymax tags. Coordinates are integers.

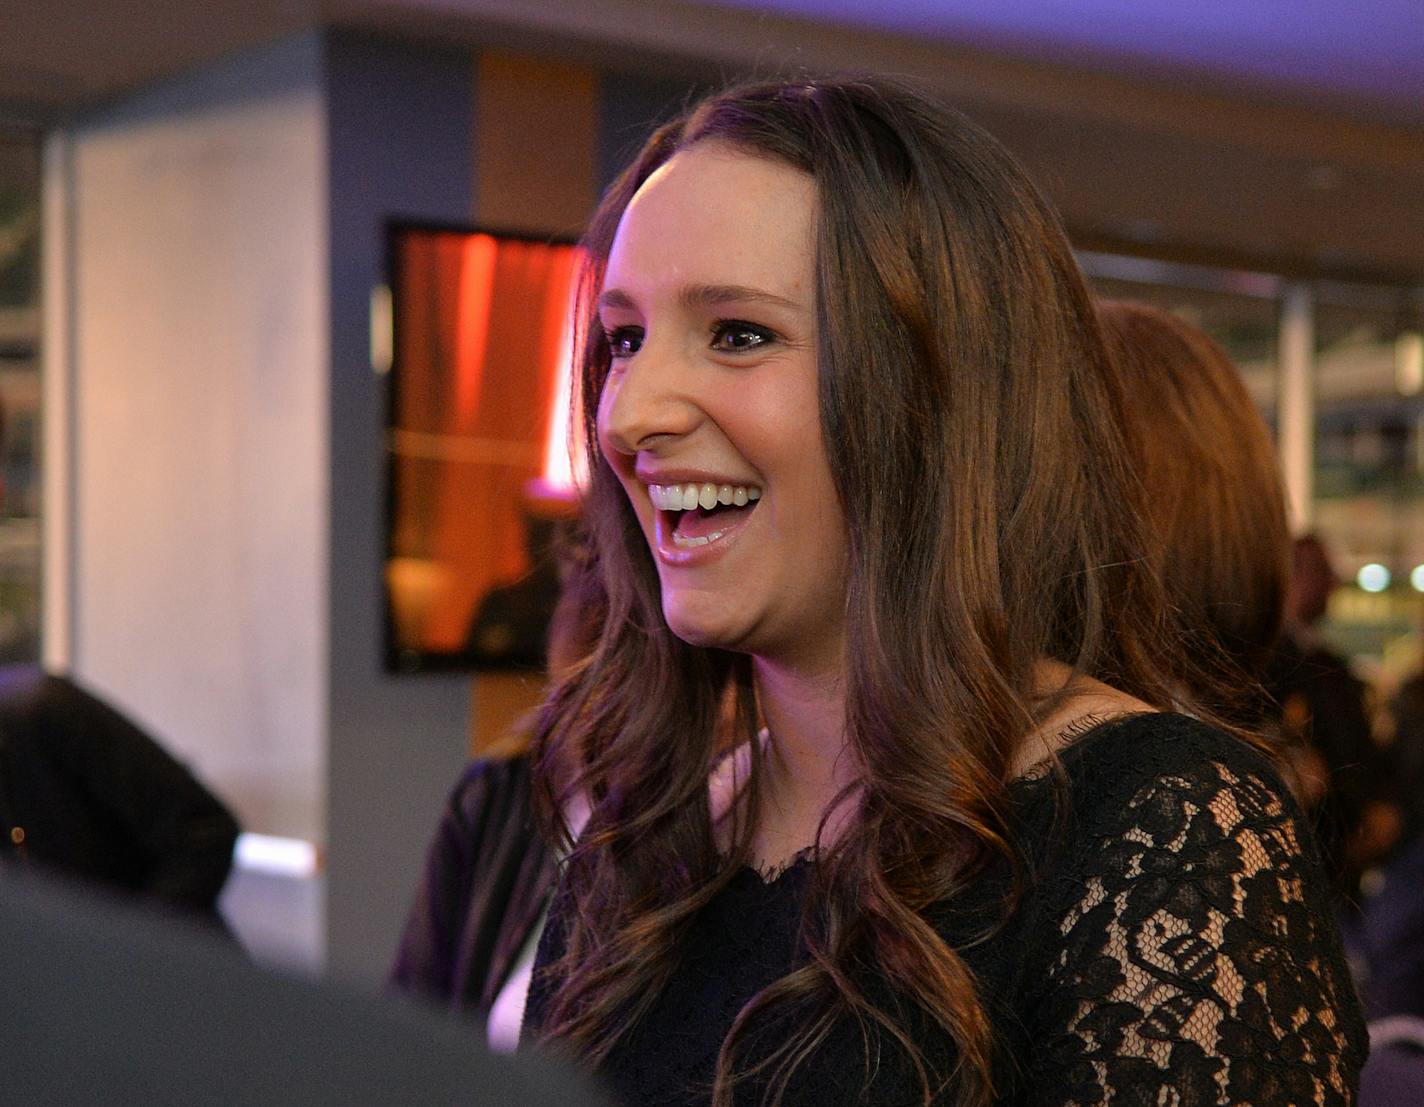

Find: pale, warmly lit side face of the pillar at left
<box><xmin>50</xmin><ymin>36</ymin><xmax>329</xmax><ymax>842</ymax></box>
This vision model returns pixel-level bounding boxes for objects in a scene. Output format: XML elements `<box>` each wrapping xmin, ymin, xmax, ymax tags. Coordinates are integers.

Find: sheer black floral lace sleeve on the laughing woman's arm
<box><xmin>1025</xmin><ymin>735</ymin><xmax>1364</xmax><ymax>1107</ymax></box>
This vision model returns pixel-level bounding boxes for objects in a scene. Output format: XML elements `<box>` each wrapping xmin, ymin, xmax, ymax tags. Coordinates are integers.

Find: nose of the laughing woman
<box><xmin>598</xmin><ymin>346</ymin><xmax>702</xmax><ymax>454</ymax></box>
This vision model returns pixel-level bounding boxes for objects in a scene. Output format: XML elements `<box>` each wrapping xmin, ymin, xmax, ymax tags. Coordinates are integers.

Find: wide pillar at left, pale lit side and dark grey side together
<box><xmin>44</xmin><ymin>33</ymin><xmax>474</xmax><ymax>983</ymax></box>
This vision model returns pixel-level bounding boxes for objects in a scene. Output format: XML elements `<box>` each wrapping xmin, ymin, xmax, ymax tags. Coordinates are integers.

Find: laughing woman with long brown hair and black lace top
<box><xmin>525</xmin><ymin>80</ymin><xmax>1363</xmax><ymax>1107</ymax></box>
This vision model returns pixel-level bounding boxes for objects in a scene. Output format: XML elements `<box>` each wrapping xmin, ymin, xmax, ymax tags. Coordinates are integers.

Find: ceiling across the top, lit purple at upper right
<box><xmin>8</xmin><ymin>0</ymin><xmax>1424</xmax><ymax>284</ymax></box>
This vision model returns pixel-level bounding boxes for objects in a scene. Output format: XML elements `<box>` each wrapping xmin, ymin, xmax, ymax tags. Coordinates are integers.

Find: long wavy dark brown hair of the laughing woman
<box><xmin>537</xmin><ymin>78</ymin><xmax>1201</xmax><ymax>1104</ymax></box>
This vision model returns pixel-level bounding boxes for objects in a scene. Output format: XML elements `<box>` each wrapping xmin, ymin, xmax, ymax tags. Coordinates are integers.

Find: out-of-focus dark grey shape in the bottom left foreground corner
<box><xmin>0</xmin><ymin>875</ymin><xmax>604</xmax><ymax>1107</ymax></box>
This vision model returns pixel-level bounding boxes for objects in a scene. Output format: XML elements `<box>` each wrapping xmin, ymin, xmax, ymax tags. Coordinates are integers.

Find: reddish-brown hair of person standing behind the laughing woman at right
<box><xmin>1098</xmin><ymin>301</ymin><xmax>1290</xmax><ymax>725</ymax></box>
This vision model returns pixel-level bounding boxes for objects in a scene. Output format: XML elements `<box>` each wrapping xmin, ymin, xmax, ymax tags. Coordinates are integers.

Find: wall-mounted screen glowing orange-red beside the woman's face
<box><xmin>384</xmin><ymin>222</ymin><xmax>580</xmax><ymax>672</ymax></box>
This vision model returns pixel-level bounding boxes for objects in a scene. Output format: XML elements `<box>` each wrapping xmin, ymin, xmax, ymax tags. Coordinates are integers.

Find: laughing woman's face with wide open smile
<box><xmin>598</xmin><ymin>142</ymin><xmax>846</xmax><ymax>668</ymax></box>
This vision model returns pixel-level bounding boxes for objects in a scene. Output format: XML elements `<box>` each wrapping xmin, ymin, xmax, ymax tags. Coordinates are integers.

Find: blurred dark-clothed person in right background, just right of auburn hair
<box><xmin>1266</xmin><ymin>533</ymin><xmax>1398</xmax><ymax>910</ymax></box>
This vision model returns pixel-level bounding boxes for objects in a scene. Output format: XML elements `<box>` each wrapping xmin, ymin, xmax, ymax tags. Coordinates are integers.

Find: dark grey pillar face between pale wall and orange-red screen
<box><xmin>326</xmin><ymin>33</ymin><xmax>474</xmax><ymax>983</ymax></box>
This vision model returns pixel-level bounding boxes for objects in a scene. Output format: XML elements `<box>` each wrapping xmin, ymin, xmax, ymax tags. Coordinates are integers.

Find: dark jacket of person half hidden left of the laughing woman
<box><xmin>390</xmin><ymin>757</ymin><xmax>555</xmax><ymax>1014</ymax></box>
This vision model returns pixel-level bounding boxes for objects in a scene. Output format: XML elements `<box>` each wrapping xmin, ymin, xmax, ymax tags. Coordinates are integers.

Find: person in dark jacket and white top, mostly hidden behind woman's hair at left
<box><xmin>389</xmin><ymin>521</ymin><xmax>604</xmax><ymax>1051</ymax></box>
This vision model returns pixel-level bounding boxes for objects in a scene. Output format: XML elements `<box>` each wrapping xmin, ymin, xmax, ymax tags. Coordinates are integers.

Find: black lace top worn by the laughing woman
<box><xmin>524</xmin><ymin>715</ymin><xmax>1366</xmax><ymax>1107</ymax></box>
